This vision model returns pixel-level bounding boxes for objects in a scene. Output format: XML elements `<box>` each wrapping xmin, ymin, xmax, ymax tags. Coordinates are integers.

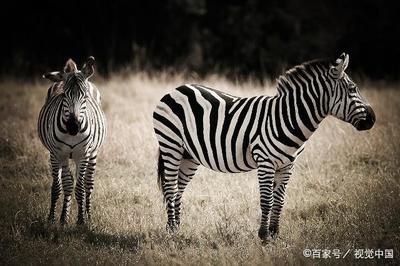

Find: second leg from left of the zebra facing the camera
<box><xmin>60</xmin><ymin>159</ymin><xmax>74</xmax><ymax>225</ymax></box>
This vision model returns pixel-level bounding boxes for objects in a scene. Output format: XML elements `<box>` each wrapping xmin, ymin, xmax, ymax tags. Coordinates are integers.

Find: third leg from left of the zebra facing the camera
<box><xmin>75</xmin><ymin>157</ymin><xmax>89</xmax><ymax>224</ymax></box>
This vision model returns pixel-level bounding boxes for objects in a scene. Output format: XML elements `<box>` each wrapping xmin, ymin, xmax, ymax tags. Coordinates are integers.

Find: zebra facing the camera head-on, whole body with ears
<box><xmin>38</xmin><ymin>56</ymin><xmax>106</xmax><ymax>225</ymax></box>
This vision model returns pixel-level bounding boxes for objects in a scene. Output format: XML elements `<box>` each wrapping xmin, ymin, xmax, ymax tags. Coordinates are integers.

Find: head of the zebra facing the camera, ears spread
<box><xmin>43</xmin><ymin>56</ymin><xmax>95</xmax><ymax>136</ymax></box>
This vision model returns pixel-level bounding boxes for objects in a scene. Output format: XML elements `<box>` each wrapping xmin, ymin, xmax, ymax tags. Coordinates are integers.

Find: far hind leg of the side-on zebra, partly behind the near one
<box><xmin>175</xmin><ymin>154</ymin><xmax>199</xmax><ymax>226</ymax></box>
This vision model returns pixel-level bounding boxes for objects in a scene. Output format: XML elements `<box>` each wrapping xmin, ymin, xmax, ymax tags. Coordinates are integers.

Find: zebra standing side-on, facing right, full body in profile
<box><xmin>153</xmin><ymin>53</ymin><xmax>375</xmax><ymax>240</ymax></box>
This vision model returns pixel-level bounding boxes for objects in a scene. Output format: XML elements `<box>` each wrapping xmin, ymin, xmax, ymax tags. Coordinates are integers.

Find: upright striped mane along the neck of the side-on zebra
<box><xmin>276</xmin><ymin>58</ymin><xmax>332</xmax><ymax>94</ymax></box>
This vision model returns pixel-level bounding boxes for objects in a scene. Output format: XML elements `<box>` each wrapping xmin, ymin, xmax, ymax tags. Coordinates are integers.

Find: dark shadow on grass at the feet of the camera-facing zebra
<box><xmin>27</xmin><ymin>218</ymin><xmax>146</xmax><ymax>252</ymax></box>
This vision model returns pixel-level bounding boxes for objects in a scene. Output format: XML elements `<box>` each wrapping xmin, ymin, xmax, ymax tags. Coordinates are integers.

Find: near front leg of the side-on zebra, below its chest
<box><xmin>258</xmin><ymin>161</ymin><xmax>275</xmax><ymax>241</ymax></box>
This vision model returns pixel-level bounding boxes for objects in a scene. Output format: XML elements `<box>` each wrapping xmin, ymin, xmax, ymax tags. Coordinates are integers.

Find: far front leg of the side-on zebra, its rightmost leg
<box><xmin>269</xmin><ymin>164</ymin><xmax>293</xmax><ymax>238</ymax></box>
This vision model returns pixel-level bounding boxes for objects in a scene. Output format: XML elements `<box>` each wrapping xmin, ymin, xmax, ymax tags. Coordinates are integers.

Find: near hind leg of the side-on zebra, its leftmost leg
<box><xmin>158</xmin><ymin>143</ymin><xmax>183</xmax><ymax>233</ymax></box>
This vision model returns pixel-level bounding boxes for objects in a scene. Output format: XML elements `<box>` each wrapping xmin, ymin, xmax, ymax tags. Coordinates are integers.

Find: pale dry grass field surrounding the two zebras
<box><xmin>0</xmin><ymin>73</ymin><xmax>400</xmax><ymax>265</ymax></box>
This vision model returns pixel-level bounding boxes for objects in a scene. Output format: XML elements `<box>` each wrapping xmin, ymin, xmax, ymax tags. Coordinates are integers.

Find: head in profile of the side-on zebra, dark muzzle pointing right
<box><xmin>329</xmin><ymin>53</ymin><xmax>375</xmax><ymax>130</ymax></box>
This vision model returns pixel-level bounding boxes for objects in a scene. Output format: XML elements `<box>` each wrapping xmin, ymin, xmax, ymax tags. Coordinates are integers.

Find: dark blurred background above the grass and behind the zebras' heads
<box><xmin>0</xmin><ymin>0</ymin><xmax>400</xmax><ymax>81</ymax></box>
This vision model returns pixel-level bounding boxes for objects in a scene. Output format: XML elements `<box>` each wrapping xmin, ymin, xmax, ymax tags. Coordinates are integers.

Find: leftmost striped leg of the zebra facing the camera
<box><xmin>48</xmin><ymin>154</ymin><xmax>61</xmax><ymax>224</ymax></box>
